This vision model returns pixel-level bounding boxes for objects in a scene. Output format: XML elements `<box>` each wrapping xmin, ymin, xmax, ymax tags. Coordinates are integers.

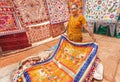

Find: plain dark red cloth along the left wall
<box><xmin>0</xmin><ymin>31</ymin><xmax>31</xmax><ymax>52</ymax></box>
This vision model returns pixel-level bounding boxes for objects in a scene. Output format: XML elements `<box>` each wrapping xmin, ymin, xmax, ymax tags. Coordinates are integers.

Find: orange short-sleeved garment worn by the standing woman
<box><xmin>68</xmin><ymin>15</ymin><xmax>86</xmax><ymax>42</ymax></box>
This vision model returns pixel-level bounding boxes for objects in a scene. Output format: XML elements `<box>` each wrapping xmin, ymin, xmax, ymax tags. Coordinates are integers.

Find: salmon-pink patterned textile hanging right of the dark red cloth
<box><xmin>26</xmin><ymin>24</ymin><xmax>51</xmax><ymax>43</ymax></box>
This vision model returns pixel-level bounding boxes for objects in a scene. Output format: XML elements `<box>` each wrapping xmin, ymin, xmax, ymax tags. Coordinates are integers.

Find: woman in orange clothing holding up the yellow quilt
<box><xmin>67</xmin><ymin>4</ymin><xmax>96</xmax><ymax>42</ymax></box>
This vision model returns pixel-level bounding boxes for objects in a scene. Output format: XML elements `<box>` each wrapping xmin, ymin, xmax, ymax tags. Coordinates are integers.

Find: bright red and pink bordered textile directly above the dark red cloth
<box><xmin>0</xmin><ymin>7</ymin><xmax>21</xmax><ymax>36</ymax></box>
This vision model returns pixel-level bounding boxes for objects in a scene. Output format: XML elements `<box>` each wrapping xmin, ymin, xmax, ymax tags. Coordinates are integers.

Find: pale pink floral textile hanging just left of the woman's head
<box><xmin>46</xmin><ymin>0</ymin><xmax>69</xmax><ymax>24</ymax></box>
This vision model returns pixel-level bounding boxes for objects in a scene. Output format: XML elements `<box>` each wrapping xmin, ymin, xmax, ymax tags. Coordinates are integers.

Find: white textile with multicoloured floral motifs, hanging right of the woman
<box><xmin>84</xmin><ymin>0</ymin><xmax>120</xmax><ymax>23</ymax></box>
